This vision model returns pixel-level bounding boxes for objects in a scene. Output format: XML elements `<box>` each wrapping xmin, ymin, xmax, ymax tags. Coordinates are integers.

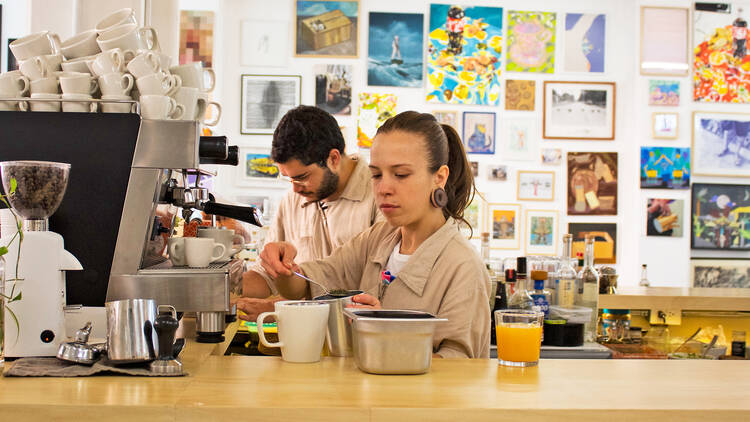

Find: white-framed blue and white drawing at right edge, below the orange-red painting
<box><xmin>692</xmin><ymin>111</ymin><xmax>750</xmax><ymax>177</ymax></box>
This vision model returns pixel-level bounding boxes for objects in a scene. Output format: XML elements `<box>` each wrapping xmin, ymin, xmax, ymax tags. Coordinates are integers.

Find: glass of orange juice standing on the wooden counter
<box><xmin>495</xmin><ymin>309</ymin><xmax>544</xmax><ymax>366</ymax></box>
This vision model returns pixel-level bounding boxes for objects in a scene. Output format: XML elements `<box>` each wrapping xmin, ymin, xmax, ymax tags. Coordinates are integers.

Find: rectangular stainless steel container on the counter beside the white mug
<box><xmin>344</xmin><ymin>309</ymin><xmax>448</xmax><ymax>374</ymax></box>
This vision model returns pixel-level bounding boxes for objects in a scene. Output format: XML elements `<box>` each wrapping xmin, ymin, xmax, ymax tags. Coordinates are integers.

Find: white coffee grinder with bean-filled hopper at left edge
<box><xmin>0</xmin><ymin>161</ymin><xmax>82</xmax><ymax>358</ymax></box>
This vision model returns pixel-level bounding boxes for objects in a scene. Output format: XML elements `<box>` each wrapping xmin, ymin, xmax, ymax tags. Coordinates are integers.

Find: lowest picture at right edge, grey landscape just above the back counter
<box><xmin>690</xmin><ymin>259</ymin><xmax>750</xmax><ymax>288</ymax></box>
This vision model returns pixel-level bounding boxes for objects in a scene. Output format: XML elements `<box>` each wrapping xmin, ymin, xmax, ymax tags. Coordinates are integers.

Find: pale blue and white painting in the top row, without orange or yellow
<box><xmin>563</xmin><ymin>13</ymin><xmax>606</xmax><ymax>73</ymax></box>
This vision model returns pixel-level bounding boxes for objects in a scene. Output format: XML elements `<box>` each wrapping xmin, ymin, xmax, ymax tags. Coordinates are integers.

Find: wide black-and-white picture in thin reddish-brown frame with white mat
<box><xmin>542</xmin><ymin>81</ymin><xmax>615</xmax><ymax>140</ymax></box>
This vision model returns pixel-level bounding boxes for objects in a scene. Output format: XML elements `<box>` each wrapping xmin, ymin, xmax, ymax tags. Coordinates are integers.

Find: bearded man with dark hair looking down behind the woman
<box><xmin>237</xmin><ymin>106</ymin><xmax>383</xmax><ymax>321</ymax></box>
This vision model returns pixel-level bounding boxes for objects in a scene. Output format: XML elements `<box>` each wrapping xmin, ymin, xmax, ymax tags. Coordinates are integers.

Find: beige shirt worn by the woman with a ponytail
<box><xmin>297</xmin><ymin>218</ymin><xmax>490</xmax><ymax>358</ymax></box>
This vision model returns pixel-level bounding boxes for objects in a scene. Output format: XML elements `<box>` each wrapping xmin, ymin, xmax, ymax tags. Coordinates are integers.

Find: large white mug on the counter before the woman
<box><xmin>256</xmin><ymin>300</ymin><xmax>330</xmax><ymax>363</ymax></box>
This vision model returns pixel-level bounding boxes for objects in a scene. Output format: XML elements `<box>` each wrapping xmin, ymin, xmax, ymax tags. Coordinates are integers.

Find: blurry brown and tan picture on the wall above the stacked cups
<box><xmin>179</xmin><ymin>10</ymin><xmax>214</xmax><ymax>67</ymax></box>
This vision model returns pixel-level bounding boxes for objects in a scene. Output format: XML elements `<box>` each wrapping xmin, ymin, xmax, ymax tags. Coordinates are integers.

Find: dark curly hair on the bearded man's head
<box><xmin>271</xmin><ymin>106</ymin><xmax>346</xmax><ymax>167</ymax></box>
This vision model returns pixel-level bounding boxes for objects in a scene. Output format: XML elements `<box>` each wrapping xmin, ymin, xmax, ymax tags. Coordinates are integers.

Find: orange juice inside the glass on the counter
<box><xmin>495</xmin><ymin>323</ymin><xmax>542</xmax><ymax>362</ymax></box>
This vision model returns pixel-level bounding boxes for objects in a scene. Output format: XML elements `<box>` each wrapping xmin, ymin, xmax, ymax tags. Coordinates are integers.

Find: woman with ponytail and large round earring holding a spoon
<box><xmin>261</xmin><ymin>111</ymin><xmax>490</xmax><ymax>358</ymax></box>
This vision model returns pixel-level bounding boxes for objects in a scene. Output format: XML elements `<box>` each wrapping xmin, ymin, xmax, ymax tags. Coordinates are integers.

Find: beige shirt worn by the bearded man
<box><xmin>251</xmin><ymin>156</ymin><xmax>383</xmax><ymax>295</ymax></box>
